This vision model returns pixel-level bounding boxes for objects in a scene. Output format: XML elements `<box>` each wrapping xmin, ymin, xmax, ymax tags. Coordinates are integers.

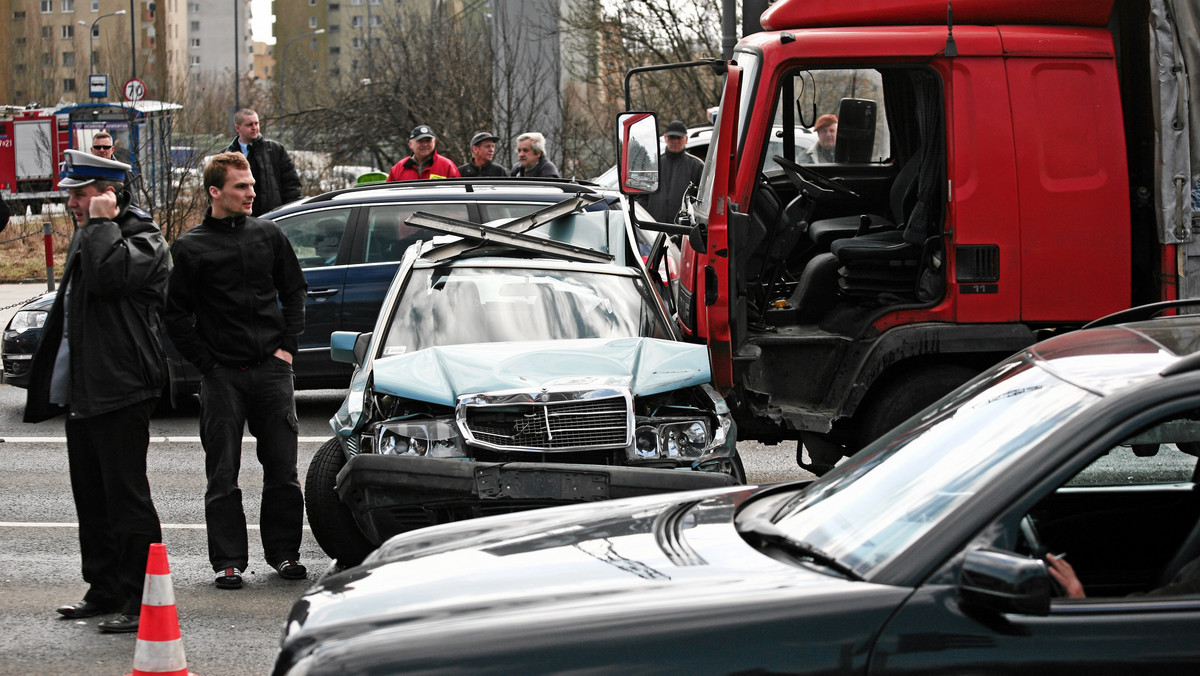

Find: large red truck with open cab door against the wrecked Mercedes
<box><xmin>617</xmin><ymin>0</ymin><xmax>1200</xmax><ymax>472</ymax></box>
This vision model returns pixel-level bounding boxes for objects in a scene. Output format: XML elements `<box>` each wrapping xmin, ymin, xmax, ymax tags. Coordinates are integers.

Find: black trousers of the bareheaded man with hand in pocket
<box><xmin>200</xmin><ymin>357</ymin><xmax>304</xmax><ymax>570</ymax></box>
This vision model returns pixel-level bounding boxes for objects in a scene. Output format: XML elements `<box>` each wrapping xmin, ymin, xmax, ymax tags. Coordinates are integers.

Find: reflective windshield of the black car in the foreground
<box><xmin>772</xmin><ymin>357</ymin><xmax>1098</xmax><ymax>576</ymax></box>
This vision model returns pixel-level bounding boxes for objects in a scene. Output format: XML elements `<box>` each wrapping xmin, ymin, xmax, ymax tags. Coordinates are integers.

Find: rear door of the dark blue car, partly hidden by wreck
<box><xmin>340</xmin><ymin>202</ymin><xmax>470</xmax><ymax>341</ymax></box>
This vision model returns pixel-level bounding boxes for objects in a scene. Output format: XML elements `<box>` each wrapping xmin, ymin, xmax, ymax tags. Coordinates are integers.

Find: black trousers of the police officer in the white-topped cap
<box><xmin>66</xmin><ymin>399</ymin><xmax>162</xmax><ymax>615</ymax></box>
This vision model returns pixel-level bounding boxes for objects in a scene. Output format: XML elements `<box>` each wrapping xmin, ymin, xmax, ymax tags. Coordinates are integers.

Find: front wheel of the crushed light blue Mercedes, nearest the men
<box><xmin>304</xmin><ymin>438</ymin><xmax>374</xmax><ymax>568</ymax></box>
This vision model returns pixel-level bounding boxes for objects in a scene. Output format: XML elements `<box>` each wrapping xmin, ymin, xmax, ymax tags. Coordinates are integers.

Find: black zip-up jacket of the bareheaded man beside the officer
<box><xmin>164</xmin><ymin>209</ymin><xmax>308</xmax><ymax>372</ymax></box>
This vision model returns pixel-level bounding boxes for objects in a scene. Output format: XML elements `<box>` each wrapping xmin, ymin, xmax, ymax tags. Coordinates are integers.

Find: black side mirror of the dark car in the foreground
<box><xmin>959</xmin><ymin>549</ymin><xmax>1051</xmax><ymax>615</ymax></box>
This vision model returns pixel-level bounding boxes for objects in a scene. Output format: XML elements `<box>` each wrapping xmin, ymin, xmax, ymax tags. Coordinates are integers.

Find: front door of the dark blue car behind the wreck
<box><xmin>275</xmin><ymin>207</ymin><xmax>354</xmax><ymax>388</ymax></box>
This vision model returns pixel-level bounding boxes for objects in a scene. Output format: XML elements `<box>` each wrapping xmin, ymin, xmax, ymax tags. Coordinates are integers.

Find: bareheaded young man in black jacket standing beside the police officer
<box><xmin>166</xmin><ymin>152</ymin><xmax>308</xmax><ymax>590</ymax></box>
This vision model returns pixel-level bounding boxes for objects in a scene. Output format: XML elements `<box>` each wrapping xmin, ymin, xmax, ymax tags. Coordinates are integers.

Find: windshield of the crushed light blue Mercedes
<box><xmin>380</xmin><ymin>265</ymin><xmax>672</xmax><ymax>357</ymax></box>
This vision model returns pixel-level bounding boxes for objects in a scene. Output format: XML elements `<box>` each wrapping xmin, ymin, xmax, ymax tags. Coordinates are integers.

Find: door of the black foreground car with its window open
<box><xmin>871</xmin><ymin>401</ymin><xmax>1200</xmax><ymax>675</ymax></box>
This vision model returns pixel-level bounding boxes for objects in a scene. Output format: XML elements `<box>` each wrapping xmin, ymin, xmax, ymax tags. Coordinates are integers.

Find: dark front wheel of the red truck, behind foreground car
<box><xmin>856</xmin><ymin>364</ymin><xmax>979</xmax><ymax>450</ymax></box>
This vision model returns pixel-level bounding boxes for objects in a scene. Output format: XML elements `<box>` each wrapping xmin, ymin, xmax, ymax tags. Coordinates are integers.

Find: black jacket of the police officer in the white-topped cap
<box><xmin>24</xmin><ymin>207</ymin><xmax>172</xmax><ymax>423</ymax></box>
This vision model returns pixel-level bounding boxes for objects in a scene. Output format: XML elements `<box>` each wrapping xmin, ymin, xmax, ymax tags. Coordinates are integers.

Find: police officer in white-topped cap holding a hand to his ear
<box><xmin>24</xmin><ymin>150</ymin><xmax>172</xmax><ymax>633</ymax></box>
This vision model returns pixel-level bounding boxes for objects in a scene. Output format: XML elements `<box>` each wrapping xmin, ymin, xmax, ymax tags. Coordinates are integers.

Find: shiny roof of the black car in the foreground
<box><xmin>1025</xmin><ymin>315</ymin><xmax>1200</xmax><ymax>395</ymax></box>
